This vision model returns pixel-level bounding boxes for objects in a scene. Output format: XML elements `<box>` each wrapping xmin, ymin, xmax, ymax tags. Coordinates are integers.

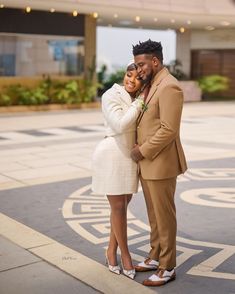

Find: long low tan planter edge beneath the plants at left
<box><xmin>0</xmin><ymin>102</ymin><xmax>101</xmax><ymax>113</ymax></box>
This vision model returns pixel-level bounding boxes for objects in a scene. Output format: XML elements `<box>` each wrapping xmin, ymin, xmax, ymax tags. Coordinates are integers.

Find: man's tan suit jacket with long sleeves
<box><xmin>137</xmin><ymin>68</ymin><xmax>187</xmax><ymax>180</ymax></box>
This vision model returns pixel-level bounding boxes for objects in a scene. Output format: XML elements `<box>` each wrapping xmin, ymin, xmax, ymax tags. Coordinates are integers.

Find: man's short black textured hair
<box><xmin>132</xmin><ymin>39</ymin><xmax>163</xmax><ymax>62</ymax></box>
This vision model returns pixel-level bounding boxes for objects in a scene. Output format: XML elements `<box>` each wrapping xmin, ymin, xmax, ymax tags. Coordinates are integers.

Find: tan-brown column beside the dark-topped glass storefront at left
<box><xmin>84</xmin><ymin>15</ymin><xmax>96</xmax><ymax>78</ymax></box>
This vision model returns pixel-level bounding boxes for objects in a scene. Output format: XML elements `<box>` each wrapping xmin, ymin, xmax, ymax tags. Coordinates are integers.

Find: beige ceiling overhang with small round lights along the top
<box><xmin>0</xmin><ymin>0</ymin><xmax>235</xmax><ymax>30</ymax></box>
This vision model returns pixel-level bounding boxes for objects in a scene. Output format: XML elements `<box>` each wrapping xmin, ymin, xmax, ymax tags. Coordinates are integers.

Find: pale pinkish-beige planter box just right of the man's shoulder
<box><xmin>180</xmin><ymin>81</ymin><xmax>202</xmax><ymax>102</ymax></box>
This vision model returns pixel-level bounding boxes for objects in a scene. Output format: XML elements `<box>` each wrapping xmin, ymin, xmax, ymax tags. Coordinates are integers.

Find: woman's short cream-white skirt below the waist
<box><xmin>92</xmin><ymin>137</ymin><xmax>138</xmax><ymax>195</ymax></box>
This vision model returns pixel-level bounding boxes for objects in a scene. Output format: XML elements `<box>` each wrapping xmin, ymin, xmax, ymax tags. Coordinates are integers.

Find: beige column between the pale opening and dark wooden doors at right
<box><xmin>176</xmin><ymin>30</ymin><xmax>191</xmax><ymax>76</ymax></box>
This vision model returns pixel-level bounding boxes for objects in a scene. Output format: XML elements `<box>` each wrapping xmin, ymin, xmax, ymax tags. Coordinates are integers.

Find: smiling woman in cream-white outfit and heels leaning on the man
<box><xmin>92</xmin><ymin>63</ymin><xmax>143</xmax><ymax>279</ymax></box>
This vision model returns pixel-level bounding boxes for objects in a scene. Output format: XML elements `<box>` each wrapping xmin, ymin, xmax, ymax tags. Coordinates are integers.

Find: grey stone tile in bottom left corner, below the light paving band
<box><xmin>0</xmin><ymin>262</ymin><xmax>100</xmax><ymax>294</ymax></box>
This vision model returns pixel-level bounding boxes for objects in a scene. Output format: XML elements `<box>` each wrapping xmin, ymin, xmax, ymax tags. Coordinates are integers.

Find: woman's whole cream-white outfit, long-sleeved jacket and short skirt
<box><xmin>92</xmin><ymin>84</ymin><xmax>141</xmax><ymax>195</ymax></box>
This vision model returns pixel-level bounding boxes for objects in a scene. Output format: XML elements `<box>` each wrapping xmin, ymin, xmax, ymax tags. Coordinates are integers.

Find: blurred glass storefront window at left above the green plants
<box><xmin>0</xmin><ymin>33</ymin><xmax>84</xmax><ymax>76</ymax></box>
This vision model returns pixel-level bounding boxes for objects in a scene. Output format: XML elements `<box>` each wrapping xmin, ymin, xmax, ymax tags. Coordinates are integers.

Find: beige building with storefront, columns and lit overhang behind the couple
<box><xmin>0</xmin><ymin>0</ymin><xmax>235</xmax><ymax>97</ymax></box>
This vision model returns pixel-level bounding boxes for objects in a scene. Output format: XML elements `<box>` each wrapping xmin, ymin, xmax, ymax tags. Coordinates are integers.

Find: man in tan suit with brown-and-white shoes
<box><xmin>131</xmin><ymin>40</ymin><xmax>187</xmax><ymax>286</ymax></box>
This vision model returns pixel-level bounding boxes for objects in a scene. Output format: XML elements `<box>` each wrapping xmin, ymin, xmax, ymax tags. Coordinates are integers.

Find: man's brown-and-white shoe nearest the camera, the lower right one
<box><xmin>143</xmin><ymin>269</ymin><xmax>176</xmax><ymax>286</ymax></box>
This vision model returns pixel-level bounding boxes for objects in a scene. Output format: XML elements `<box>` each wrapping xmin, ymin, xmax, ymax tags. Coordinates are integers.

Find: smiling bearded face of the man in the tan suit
<box><xmin>134</xmin><ymin>54</ymin><xmax>157</xmax><ymax>82</ymax></box>
